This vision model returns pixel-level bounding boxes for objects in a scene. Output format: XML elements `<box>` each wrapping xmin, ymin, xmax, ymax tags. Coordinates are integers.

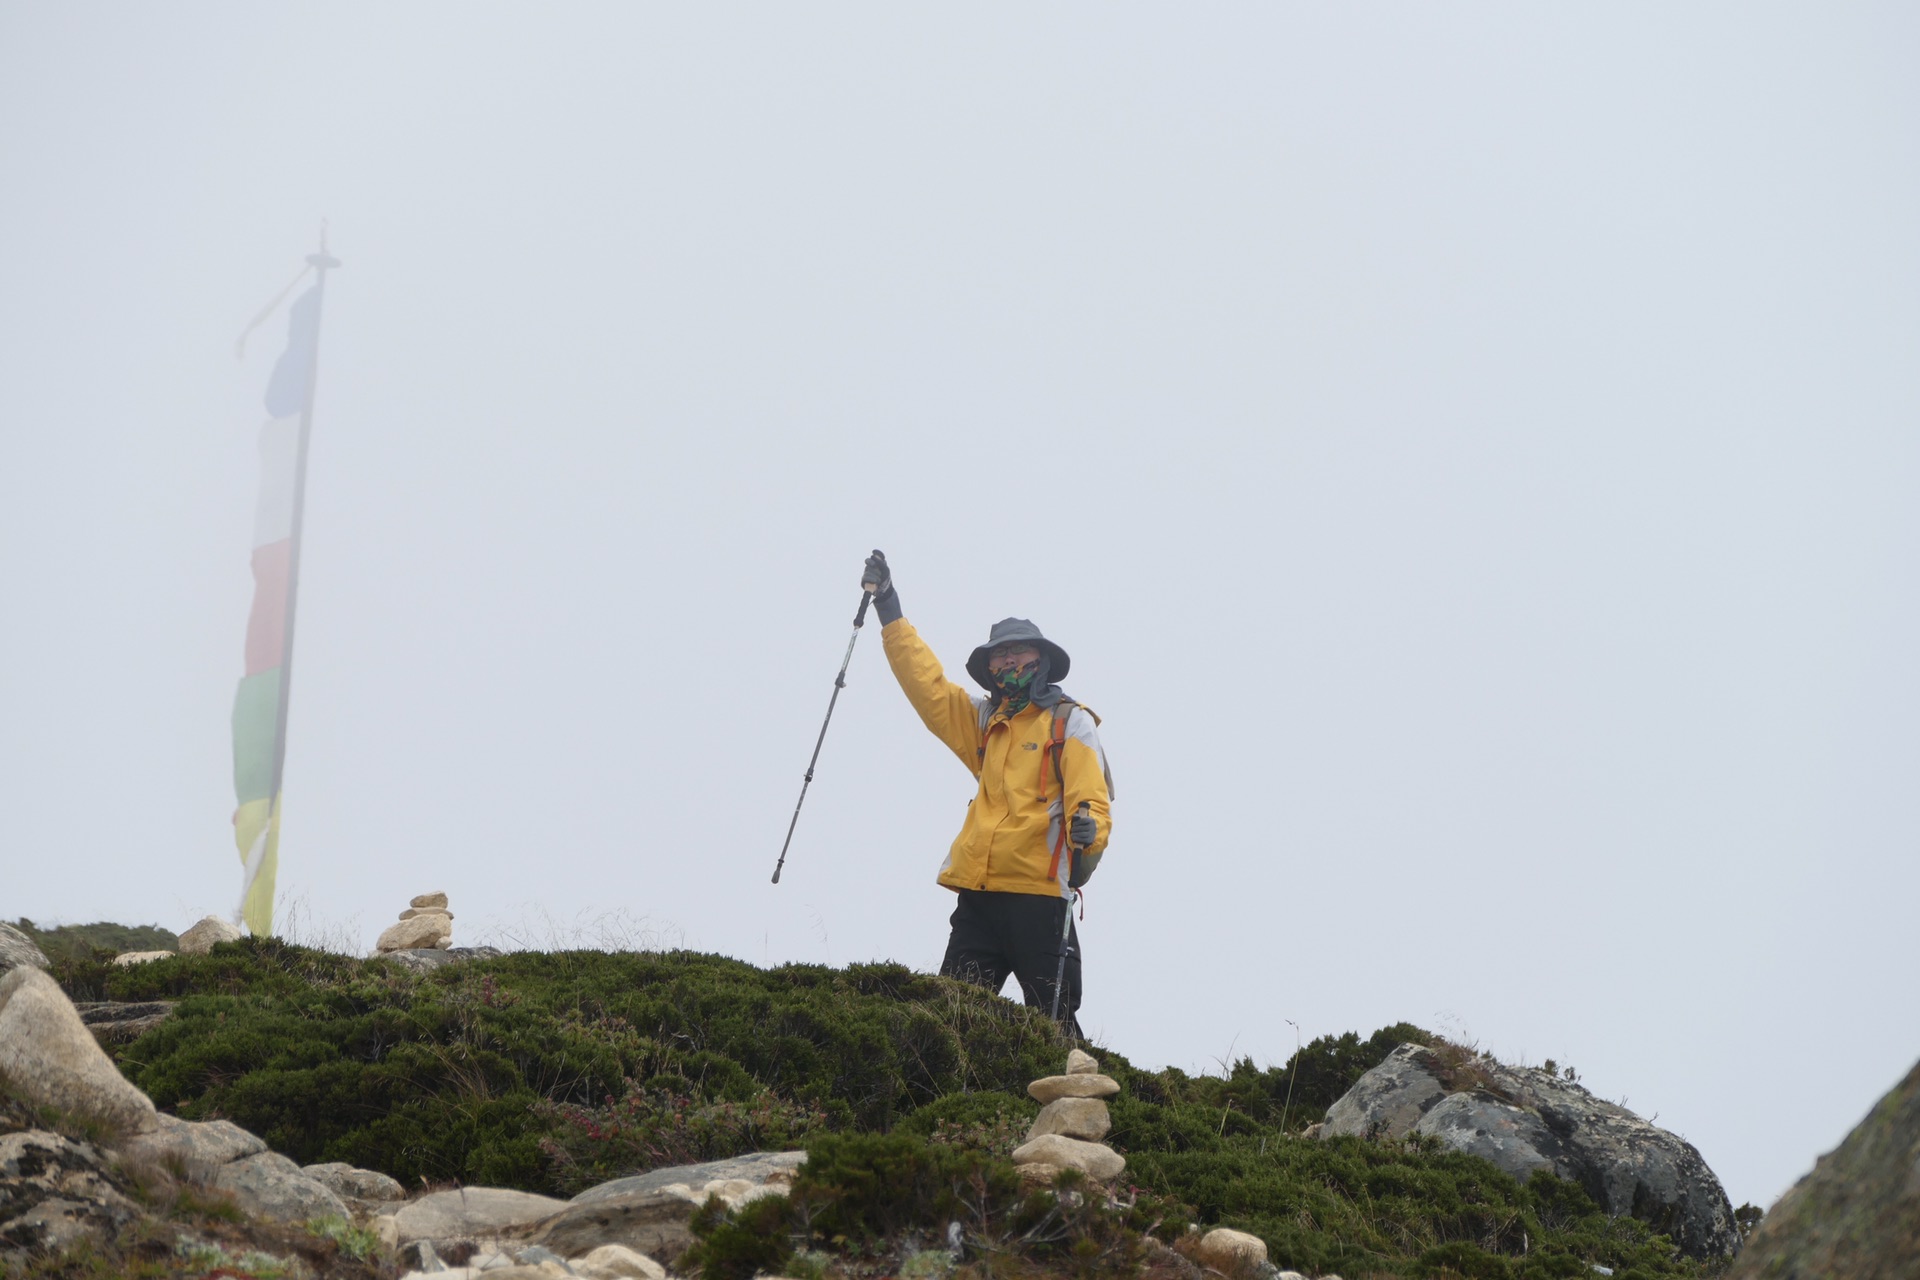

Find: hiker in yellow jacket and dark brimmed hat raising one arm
<box><xmin>860</xmin><ymin>551</ymin><xmax>1112</xmax><ymax>1034</ymax></box>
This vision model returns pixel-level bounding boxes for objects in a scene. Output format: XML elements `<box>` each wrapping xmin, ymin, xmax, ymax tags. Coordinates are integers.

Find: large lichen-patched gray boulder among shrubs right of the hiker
<box><xmin>1317</xmin><ymin>1044</ymin><xmax>1740</xmax><ymax>1259</ymax></box>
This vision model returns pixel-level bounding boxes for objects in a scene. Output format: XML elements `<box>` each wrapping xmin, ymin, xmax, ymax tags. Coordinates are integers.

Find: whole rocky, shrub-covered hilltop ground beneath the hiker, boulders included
<box><xmin>18</xmin><ymin>921</ymin><xmax>1920</xmax><ymax>1280</ymax></box>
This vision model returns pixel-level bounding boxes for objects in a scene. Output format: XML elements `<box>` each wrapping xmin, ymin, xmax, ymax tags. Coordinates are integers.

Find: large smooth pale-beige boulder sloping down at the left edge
<box><xmin>0</xmin><ymin>965</ymin><xmax>156</xmax><ymax>1134</ymax></box>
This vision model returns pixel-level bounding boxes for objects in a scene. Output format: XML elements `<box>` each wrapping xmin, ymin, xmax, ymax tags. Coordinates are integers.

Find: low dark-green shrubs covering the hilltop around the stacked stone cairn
<box><xmin>63</xmin><ymin>938</ymin><xmax>1709</xmax><ymax>1280</ymax></box>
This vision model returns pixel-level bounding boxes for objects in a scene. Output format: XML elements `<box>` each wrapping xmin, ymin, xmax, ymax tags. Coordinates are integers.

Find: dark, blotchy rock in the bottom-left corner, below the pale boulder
<box><xmin>0</xmin><ymin>1128</ymin><xmax>140</xmax><ymax>1268</ymax></box>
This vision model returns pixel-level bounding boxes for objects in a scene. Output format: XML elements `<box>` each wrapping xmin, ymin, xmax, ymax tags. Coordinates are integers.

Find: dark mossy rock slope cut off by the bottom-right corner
<box><xmin>1726</xmin><ymin>1063</ymin><xmax>1920</xmax><ymax>1280</ymax></box>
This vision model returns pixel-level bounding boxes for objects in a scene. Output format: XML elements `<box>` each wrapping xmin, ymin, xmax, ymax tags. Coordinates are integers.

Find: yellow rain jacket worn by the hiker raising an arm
<box><xmin>879</xmin><ymin>618</ymin><xmax>1112</xmax><ymax>898</ymax></box>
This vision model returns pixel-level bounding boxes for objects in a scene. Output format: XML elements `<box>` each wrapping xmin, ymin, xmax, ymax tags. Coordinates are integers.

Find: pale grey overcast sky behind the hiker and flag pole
<box><xmin>0</xmin><ymin>0</ymin><xmax>1920</xmax><ymax>1203</ymax></box>
